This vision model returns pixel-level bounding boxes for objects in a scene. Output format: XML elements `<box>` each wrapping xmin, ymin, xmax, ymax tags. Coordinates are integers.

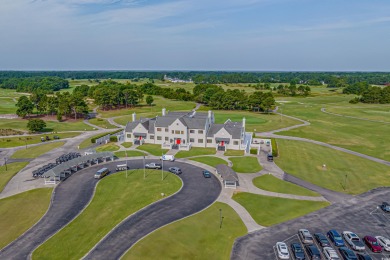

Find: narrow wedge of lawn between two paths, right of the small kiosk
<box><xmin>253</xmin><ymin>174</ymin><xmax>321</xmax><ymax>197</ymax></box>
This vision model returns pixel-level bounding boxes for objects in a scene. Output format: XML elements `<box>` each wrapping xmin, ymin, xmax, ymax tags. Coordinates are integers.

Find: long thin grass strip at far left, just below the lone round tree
<box><xmin>0</xmin><ymin>132</ymin><xmax>81</xmax><ymax>148</ymax></box>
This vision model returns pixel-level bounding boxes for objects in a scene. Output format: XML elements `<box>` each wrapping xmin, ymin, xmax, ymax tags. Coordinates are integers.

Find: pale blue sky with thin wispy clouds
<box><xmin>0</xmin><ymin>0</ymin><xmax>390</xmax><ymax>72</ymax></box>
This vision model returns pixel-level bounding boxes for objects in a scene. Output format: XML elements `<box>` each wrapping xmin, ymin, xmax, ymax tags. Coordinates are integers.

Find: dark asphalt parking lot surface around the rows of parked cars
<box><xmin>231</xmin><ymin>188</ymin><xmax>390</xmax><ymax>260</ymax></box>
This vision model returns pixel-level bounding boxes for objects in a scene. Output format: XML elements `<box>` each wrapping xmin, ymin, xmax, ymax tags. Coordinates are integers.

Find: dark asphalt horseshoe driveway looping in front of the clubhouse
<box><xmin>0</xmin><ymin>160</ymin><xmax>221</xmax><ymax>259</ymax></box>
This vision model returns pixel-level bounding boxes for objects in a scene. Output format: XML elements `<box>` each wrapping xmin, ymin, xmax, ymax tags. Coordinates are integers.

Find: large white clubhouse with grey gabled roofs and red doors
<box><xmin>125</xmin><ymin>108</ymin><xmax>251</xmax><ymax>151</ymax></box>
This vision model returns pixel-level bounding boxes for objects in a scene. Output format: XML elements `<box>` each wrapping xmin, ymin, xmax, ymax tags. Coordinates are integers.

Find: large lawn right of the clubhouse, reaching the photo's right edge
<box><xmin>274</xmin><ymin>139</ymin><xmax>390</xmax><ymax>194</ymax></box>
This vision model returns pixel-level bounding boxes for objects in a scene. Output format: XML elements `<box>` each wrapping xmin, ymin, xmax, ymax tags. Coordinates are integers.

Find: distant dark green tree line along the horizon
<box><xmin>0</xmin><ymin>71</ymin><xmax>390</xmax><ymax>87</ymax></box>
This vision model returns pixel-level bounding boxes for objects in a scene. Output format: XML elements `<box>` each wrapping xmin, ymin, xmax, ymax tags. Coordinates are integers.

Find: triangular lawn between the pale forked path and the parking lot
<box><xmin>233</xmin><ymin>192</ymin><xmax>330</xmax><ymax>227</ymax></box>
